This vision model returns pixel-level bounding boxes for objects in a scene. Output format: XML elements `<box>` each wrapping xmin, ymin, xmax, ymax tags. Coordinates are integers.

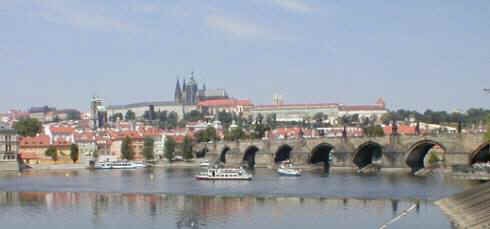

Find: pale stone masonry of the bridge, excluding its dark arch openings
<box><xmin>196</xmin><ymin>134</ymin><xmax>483</xmax><ymax>168</ymax></box>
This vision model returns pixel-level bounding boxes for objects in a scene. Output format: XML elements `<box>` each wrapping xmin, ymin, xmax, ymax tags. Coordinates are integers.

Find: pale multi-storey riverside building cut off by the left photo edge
<box><xmin>0</xmin><ymin>122</ymin><xmax>19</xmax><ymax>170</ymax></box>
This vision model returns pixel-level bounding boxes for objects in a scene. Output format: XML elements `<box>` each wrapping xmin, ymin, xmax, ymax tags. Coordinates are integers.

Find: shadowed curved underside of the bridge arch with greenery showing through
<box><xmin>406</xmin><ymin>139</ymin><xmax>447</xmax><ymax>172</ymax></box>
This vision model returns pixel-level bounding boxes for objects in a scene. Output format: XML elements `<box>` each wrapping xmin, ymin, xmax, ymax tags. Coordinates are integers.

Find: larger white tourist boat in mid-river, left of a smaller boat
<box><xmin>196</xmin><ymin>167</ymin><xmax>252</xmax><ymax>180</ymax></box>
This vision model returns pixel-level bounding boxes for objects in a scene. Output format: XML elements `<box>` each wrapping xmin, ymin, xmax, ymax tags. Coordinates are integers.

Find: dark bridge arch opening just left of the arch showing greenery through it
<box><xmin>353</xmin><ymin>141</ymin><xmax>383</xmax><ymax>169</ymax></box>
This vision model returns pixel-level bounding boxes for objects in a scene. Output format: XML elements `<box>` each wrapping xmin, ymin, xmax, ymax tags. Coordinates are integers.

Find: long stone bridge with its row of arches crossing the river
<box><xmin>196</xmin><ymin>134</ymin><xmax>490</xmax><ymax>172</ymax></box>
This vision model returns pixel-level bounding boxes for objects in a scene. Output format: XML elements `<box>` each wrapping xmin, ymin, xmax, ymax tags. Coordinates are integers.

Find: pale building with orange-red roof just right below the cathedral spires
<box><xmin>197</xmin><ymin>99</ymin><xmax>253</xmax><ymax>116</ymax></box>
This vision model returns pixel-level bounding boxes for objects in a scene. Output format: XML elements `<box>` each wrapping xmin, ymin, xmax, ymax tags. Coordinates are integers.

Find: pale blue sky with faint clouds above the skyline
<box><xmin>0</xmin><ymin>0</ymin><xmax>490</xmax><ymax>112</ymax></box>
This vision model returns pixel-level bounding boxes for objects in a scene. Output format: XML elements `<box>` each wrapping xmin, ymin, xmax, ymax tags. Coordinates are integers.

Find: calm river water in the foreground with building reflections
<box><xmin>0</xmin><ymin>169</ymin><xmax>473</xmax><ymax>229</ymax></box>
